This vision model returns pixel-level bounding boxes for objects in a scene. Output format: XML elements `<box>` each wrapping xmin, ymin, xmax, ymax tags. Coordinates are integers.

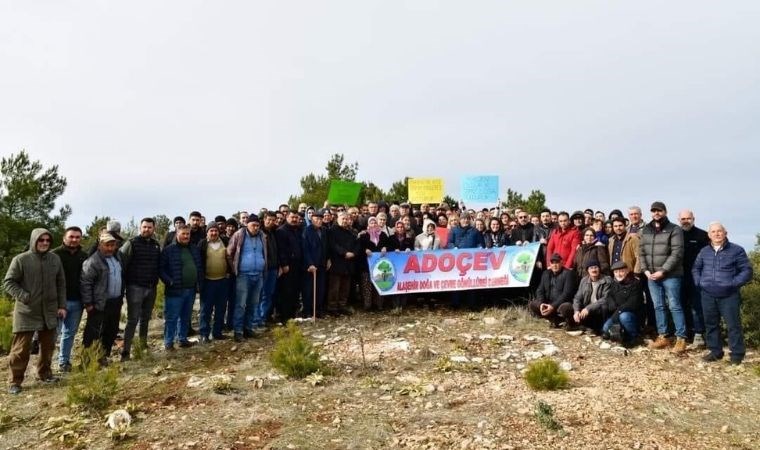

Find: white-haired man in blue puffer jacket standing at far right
<box><xmin>691</xmin><ymin>222</ymin><xmax>752</xmax><ymax>364</ymax></box>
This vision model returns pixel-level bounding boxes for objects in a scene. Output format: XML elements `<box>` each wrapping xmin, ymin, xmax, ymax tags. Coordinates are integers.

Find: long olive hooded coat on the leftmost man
<box><xmin>3</xmin><ymin>228</ymin><xmax>66</xmax><ymax>333</ymax></box>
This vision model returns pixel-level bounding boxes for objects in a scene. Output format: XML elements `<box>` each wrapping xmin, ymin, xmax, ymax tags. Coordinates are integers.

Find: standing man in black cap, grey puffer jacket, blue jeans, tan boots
<box><xmin>639</xmin><ymin>202</ymin><xmax>686</xmax><ymax>354</ymax></box>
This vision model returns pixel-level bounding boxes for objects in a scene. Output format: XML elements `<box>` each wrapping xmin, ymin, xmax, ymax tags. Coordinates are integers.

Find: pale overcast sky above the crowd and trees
<box><xmin>0</xmin><ymin>0</ymin><xmax>760</xmax><ymax>247</ymax></box>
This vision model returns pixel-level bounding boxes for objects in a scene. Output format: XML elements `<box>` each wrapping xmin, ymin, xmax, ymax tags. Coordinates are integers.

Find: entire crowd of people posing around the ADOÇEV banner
<box><xmin>4</xmin><ymin>202</ymin><xmax>752</xmax><ymax>393</ymax></box>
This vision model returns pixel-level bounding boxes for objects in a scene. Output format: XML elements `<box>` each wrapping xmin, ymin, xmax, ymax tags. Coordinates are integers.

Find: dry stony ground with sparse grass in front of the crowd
<box><xmin>0</xmin><ymin>307</ymin><xmax>760</xmax><ymax>450</ymax></box>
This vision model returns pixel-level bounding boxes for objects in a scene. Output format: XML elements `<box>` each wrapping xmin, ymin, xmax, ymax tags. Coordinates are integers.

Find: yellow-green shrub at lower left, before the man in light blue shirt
<box><xmin>66</xmin><ymin>343</ymin><xmax>119</xmax><ymax>412</ymax></box>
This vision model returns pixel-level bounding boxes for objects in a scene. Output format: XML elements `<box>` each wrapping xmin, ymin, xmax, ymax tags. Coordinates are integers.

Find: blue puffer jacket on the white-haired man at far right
<box><xmin>691</xmin><ymin>240</ymin><xmax>752</xmax><ymax>297</ymax></box>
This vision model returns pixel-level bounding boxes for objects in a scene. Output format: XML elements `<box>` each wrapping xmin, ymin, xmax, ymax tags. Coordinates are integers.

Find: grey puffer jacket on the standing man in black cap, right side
<box><xmin>639</xmin><ymin>217</ymin><xmax>683</xmax><ymax>278</ymax></box>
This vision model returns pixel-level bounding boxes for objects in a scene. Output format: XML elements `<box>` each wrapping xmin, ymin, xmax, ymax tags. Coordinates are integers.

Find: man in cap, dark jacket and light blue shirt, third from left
<box><xmin>81</xmin><ymin>232</ymin><xmax>124</xmax><ymax>366</ymax></box>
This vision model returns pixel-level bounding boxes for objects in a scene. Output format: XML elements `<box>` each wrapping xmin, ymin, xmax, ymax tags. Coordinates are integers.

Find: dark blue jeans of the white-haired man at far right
<box><xmin>702</xmin><ymin>291</ymin><xmax>746</xmax><ymax>361</ymax></box>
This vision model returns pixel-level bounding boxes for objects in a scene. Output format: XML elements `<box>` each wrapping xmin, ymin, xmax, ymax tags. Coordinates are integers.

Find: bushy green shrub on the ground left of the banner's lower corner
<box><xmin>269</xmin><ymin>321</ymin><xmax>326</xmax><ymax>378</ymax></box>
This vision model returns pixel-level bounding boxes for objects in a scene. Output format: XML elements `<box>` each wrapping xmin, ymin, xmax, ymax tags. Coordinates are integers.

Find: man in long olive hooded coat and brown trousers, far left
<box><xmin>3</xmin><ymin>228</ymin><xmax>66</xmax><ymax>395</ymax></box>
